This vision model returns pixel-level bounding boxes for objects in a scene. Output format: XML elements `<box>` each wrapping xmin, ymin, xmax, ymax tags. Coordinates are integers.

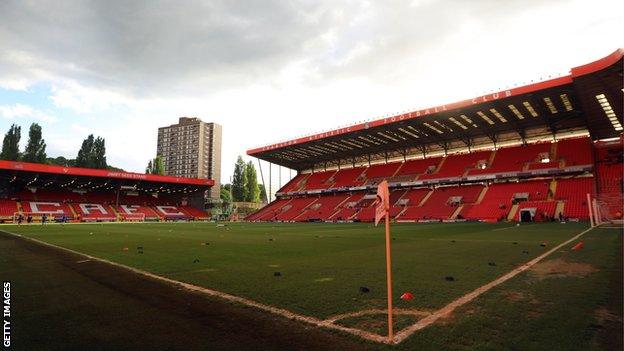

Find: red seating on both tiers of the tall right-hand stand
<box><xmin>248</xmin><ymin>137</ymin><xmax>624</xmax><ymax>221</ymax></box>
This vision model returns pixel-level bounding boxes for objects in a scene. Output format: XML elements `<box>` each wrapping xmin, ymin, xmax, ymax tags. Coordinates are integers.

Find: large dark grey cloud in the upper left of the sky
<box><xmin>0</xmin><ymin>1</ymin><xmax>342</xmax><ymax>97</ymax></box>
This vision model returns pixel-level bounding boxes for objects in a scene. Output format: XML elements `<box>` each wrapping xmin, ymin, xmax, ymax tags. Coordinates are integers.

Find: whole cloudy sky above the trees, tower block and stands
<box><xmin>0</xmin><ymin>0</ymin><xmax>624</xmax><ymax>187</ymax></box>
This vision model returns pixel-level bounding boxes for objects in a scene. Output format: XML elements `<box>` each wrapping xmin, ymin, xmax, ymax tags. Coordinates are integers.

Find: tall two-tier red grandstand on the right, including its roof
<box><xmin>247</xmin><ymin>49</ymin><xmax>624</xmax><ymax>222</ymax></box>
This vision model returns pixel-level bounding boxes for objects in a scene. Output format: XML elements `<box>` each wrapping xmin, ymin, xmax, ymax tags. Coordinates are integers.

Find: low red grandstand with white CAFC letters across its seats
<box><xmin>0</xmin><ymin>160</ymin><xmax>214</xmax><ymax>222</ymax></box>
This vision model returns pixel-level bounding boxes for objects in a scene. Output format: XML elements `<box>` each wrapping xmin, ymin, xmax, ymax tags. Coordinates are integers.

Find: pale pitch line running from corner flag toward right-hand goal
<box><xmin>393</xmin><ymin>227</ymin><xmax>594</xmax><ymax>344</ymax></box>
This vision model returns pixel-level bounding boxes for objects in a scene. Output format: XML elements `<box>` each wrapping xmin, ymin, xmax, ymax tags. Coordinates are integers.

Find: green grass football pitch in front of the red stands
<box><xmin>1</xmin><ymin>223</ymin><xmax>621</xmax><ymax>348</ymax></box>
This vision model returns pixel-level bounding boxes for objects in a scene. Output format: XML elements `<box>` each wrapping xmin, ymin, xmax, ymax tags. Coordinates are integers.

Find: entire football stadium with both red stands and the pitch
<box><xmin>0</xmin><ymin>45</ymin><xmax>624</xmax><ymax>350</ymax></box>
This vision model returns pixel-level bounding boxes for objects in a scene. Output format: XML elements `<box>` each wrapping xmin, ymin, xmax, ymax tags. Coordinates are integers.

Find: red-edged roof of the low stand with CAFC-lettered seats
<box><xmin>0</xmin><ymin>160</ymin><xmax>214</xmax><ymax>192</ymax></box>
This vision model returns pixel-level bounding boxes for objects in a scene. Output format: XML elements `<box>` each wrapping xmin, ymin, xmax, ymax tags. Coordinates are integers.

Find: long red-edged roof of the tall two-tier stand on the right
<box><xmin>247</xmin><ymin>49</ymin><xmax>624</xmax><ymax>170</ymax></box>
